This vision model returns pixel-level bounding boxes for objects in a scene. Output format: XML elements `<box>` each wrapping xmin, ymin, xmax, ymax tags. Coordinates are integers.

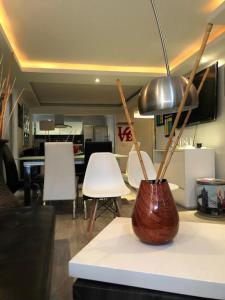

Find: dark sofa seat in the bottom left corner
<box><xmin>0</xmin><ymin>207</ymin><xmax>55</xmax><ymax>300</ymax></box>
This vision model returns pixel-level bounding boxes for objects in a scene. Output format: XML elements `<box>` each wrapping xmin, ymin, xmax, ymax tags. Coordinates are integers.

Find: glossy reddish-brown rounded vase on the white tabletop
<box><xmin>132</xmin><ymin>179</ymin><xmax>179</xmax><ymax>245</ymax></box>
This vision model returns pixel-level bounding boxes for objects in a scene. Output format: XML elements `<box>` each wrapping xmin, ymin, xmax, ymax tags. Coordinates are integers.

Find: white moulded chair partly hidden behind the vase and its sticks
<box><xmin>127</xmin><ymin>151</ymin><xmax>179</xmax><ymax>191</ymax></box>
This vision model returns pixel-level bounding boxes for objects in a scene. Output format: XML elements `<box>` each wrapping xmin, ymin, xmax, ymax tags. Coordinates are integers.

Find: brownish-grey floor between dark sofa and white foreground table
<box><xmin>50</xmin><ymin>193</ymin><xmax>225</xmax><ymax>300</ymax></box>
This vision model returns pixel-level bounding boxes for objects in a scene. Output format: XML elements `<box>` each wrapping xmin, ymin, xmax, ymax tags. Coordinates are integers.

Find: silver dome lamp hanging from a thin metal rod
<box><xmin>138</xmin><ymin>0</ymin><xmax>198</xmax><ymax>116</ymax></box>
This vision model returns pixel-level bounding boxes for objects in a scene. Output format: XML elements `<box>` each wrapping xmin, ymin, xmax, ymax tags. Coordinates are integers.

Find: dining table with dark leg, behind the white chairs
<box><xmin>16</xmin><ymin>153</ymin><xmax>127</xmax><ymax>205</ymax></box>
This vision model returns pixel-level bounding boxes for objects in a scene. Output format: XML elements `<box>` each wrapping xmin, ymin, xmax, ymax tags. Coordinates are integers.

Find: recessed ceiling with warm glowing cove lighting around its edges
<box><xmin>0</xmin><ymin>0</ymin><xmax>225</xmax><ymax>111</ymax></box>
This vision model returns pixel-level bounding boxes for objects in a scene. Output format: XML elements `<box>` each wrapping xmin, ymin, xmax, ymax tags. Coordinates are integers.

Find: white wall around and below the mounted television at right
<box><xmin>156</xmin><ymin>66</ymin><xmax>225</xmax><ymax>178</ymax></box>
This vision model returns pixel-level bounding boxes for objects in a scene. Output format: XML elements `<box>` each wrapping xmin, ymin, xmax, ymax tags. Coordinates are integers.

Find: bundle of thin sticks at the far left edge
<box><xmin>0</xmin><ymin>54</ymin><xmax>24</xmax><ymax>138</ymax></box>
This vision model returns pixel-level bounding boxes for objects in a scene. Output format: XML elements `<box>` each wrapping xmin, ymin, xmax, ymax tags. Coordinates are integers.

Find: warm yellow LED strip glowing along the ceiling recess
<box><xmin>0</xmin><ymin>0</ymin><xmax>225</xmax><ymax>75</ymax></box>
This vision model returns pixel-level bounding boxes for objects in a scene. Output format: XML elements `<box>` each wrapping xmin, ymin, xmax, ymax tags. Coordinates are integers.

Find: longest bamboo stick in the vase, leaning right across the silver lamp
<box><xmin>156</xmin><ymin>23</ymin><xmax>213</xmax><ymax>181</ymax></box>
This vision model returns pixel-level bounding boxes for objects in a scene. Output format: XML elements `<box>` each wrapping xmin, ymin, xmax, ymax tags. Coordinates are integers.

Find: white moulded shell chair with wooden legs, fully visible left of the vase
<box><xmin>83</xmin><ymin>152</ymin><xmax>130</xmax><ymax>235</ymax></box>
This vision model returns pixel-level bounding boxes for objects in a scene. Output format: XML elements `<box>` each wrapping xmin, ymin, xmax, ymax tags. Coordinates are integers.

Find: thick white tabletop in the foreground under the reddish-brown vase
<box><xmin>69</xmin><ymin>218</ymin><xmax>225</xmax><ymax>299</ymax></box>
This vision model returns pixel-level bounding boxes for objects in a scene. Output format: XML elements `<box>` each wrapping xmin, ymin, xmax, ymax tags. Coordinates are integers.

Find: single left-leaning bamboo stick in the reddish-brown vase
<box><xmin>116</xmin><ymin>79</ymin><xmax>148</xmax><ymax>180</ymax></box>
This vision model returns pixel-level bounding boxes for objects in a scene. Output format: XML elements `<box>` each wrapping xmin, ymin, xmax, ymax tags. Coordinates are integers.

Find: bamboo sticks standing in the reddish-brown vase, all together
<box><xmin>116</xmin><ymin>23</ymin><xmax>213</xmax><ymax>183</ymax></box>
